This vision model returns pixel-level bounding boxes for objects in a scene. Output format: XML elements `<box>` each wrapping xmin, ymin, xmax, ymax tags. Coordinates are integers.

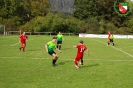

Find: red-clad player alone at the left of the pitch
<box><xmin>19</xmin><ymin>32</ymin><xmax>28</xmax><ymax>52</ymax></box>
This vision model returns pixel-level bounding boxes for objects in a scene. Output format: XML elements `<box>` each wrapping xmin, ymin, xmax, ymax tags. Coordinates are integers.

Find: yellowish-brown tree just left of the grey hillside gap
<box><xmin>23</xmin><ymin>0</ymin><xmax>50</xmax><ymax>17</ymax></box>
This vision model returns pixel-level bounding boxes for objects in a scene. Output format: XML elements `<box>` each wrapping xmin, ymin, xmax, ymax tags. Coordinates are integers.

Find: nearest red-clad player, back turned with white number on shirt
<box><xmin>73</xmin><ymin>40</ymin><xmax>89</xmax><ymax>69</ymax></box>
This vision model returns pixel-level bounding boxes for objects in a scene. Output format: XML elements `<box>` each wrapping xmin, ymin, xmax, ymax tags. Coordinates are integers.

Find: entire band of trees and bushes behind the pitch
<box><xmin>0</xmin><ymin>0</ymin><xmax>133</xmax><ymax>34</ymax></box>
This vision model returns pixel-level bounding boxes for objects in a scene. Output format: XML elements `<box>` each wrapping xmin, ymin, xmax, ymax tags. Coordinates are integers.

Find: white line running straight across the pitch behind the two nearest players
<box><xmin>0</xmin><ymin>57</ymin><xmax>133</xmax><ymax>62</ymax></box>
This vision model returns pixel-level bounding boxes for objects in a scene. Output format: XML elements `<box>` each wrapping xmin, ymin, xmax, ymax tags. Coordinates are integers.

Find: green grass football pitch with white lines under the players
<box><xmin>0</xmin><ymin>35</ymin><xmax>133</xmax><ymax>88</ymax></box>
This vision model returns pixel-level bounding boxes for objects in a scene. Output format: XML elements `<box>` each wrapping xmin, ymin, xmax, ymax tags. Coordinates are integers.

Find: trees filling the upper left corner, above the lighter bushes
<box><xmin>0</xmin><ymin>0</ymin><xmax>50</xmax><ymax>30</ymax></box>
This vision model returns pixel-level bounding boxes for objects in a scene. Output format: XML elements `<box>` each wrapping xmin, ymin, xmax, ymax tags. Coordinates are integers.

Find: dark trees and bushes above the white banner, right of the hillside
<box><xmin>73</xmin><ymin>0</ymin><xmax>133</xmax><ymax>34</ymax></box>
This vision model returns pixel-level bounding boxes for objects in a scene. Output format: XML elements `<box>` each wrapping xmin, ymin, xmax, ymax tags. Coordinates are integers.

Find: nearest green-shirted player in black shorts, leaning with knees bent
<box><xmin>45</xmin><ymin>37</ymin><xmax>61</xmax><ymax>66</ymax></box>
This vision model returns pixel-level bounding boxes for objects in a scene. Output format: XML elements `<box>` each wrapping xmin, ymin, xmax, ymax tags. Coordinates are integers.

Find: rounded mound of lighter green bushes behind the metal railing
<box><xmin>22</xmin><ymin>13</ymin><xmax>81</xmax><ymax>33</ymax></box>
